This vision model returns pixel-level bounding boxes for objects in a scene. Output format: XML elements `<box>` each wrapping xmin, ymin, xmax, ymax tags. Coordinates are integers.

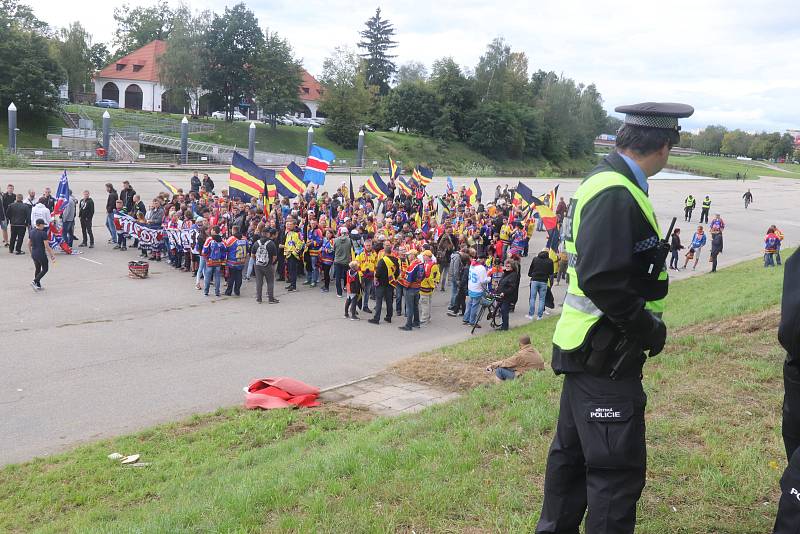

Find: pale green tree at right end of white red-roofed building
<box><xmin>158</xmin><ymin>8</ymin><xmax>211</xmax><ymax>115</ymax></box>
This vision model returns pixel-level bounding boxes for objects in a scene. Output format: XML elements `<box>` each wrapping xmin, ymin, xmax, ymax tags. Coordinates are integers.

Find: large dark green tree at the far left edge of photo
<box><xmin>0</xmin><ymin>0</ymin><xmax>65</xmax><ymax>113</ymax></box>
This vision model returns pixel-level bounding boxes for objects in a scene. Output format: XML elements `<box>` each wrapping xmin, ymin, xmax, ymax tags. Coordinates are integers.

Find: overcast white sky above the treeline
<box><xmin>28</xmin><ymin>0</ymin><xmax>800</xmax><ymax>131</ymax></box>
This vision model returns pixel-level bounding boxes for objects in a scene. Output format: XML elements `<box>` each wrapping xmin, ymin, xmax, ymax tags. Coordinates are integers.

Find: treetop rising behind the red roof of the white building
<box><xmin>114</xmin><ymin>0</ymin><xmax>182</xmax><ymax>57</ymax></box>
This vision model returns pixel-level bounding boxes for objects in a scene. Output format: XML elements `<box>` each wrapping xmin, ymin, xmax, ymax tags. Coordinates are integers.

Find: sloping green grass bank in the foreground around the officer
<box><xmin>0</xmin><ymin>251</ymin><xmax>789</xmax><ymax>534</ymax></box>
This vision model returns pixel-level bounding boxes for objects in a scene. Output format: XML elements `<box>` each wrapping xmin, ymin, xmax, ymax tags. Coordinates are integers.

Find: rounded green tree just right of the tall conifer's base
<box><xmin>386</xmin><ymin>82</ymin><xmax>439</xmax><ymax>134</ymax></box>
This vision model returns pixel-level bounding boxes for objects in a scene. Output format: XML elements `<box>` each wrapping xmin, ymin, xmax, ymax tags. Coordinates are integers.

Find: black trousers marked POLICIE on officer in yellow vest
<box><xmin>536</xmin><ymin>373</ymin><xmax>647</xmax><ymax>534</ymax></box>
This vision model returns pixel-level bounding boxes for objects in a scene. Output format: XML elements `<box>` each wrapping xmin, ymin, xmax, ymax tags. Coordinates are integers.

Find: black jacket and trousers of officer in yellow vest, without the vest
<box><xmin>536</xmin><ymin>153</ymin><xmax>668</xmax><ymax>533</ymax></box>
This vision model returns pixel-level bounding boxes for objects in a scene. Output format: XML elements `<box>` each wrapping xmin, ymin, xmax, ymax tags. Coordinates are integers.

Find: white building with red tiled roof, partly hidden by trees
<box><xmin>94</xmin><ymin>40</ymin><xmax>324</xmax><ymax>118</ymax></box>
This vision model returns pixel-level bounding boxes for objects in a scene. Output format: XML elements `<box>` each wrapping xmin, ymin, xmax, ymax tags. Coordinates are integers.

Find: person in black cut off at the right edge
<box><xmin>774</xmin><ymin>253</ymin><xmax>800</xmax><ymax>534</ymax></box>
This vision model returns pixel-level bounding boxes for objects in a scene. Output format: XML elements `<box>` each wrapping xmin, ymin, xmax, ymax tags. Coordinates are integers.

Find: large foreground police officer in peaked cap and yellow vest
<box><xmin>536</xmin><ymin>102</ymin><xmax>694</xmax><ymax>534</ymax></box>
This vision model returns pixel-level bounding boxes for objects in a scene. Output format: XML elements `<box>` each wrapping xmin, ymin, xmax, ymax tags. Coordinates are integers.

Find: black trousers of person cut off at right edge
<box><xmin>774</xmin><ymin>363</ymin><xmax>800</xmax><ymax>534</ymax></box>
